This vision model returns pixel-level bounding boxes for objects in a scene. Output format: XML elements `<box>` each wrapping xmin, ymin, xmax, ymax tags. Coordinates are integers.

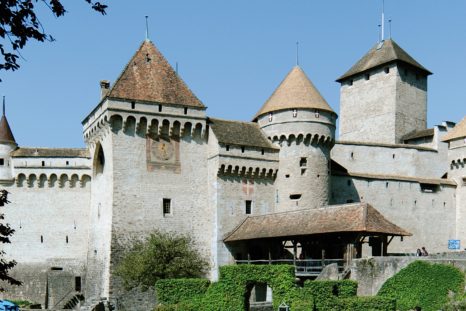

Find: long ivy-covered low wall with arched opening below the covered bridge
<box><xmin>155</xmin><ymin>265</ymin><xmax>395</xmax><ymax>311</ymax></box>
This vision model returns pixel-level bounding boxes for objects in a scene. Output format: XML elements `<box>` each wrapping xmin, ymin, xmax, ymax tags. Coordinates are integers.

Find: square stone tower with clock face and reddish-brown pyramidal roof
<box><xmin>83</xmin><ymin>40</ymin><xmax>213</xmax><ymax>310</ymax></box>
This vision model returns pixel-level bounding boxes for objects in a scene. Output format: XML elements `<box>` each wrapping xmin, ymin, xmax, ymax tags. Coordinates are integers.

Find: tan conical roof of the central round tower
<box><xmin>254</xmin><ymin>66</ymin><xmax>335</xmax><ymax>120</ymax></box>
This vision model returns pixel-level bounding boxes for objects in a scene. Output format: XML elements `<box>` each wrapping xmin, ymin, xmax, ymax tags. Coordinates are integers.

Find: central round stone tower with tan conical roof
<box><xmin>254</xmin><ymin>66</ymin><xmax>337</xmax><ymax>211</ymax></box>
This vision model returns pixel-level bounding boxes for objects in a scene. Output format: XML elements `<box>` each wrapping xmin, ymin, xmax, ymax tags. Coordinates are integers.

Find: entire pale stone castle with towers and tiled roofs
<box><xmin>0</xmin><ymin>35</ymin><xmax>466</xmax><ymax>308</ymax></box>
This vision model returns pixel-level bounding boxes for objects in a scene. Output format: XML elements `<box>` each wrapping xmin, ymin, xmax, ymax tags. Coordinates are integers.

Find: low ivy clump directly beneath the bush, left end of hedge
<box><xmin>155</xmin><ymin>279</ymin><xmax>210</xmax><ymax>304</ymax></box>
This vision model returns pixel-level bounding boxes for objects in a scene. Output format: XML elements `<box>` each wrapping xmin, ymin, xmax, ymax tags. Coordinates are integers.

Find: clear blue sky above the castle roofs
<box><xmin>0</xmin><ymin>0</ymin><xmax>466</xmax><ymax>147</ymax></box>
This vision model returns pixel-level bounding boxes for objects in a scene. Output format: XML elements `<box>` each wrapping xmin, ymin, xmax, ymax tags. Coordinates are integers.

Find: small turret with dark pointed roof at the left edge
<box><xmin>0</xmin><ymin>97</ymin><xmax>18</xmax><ymax>181</ymax></box>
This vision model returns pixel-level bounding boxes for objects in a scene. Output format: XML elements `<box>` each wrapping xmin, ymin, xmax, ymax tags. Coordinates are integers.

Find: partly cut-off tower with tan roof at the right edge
<box><xmin>442</xmin><ymin>117</ymin><xmax>466</xmax><ymax>244</ymax></box>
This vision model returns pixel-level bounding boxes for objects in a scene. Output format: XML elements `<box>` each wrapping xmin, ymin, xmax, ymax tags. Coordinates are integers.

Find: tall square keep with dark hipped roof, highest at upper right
<box><xmin>337</xmin><ymin>39</ymin><xmax>431</xmax><ymax>144</ymax></box>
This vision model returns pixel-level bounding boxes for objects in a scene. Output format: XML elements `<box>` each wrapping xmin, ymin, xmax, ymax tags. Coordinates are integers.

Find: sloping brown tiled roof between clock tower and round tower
<box><xmin>209</xmin><ymin>118</ymin><xmax>278</xmax><ymax>149</ymax></box>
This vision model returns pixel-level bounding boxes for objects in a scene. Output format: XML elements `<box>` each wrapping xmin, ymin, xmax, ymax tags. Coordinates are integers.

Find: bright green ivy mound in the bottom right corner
<box><xmin>377</xmin><ymin>261</ymin><xmax>464</xmax><ymax>311</ymax></box>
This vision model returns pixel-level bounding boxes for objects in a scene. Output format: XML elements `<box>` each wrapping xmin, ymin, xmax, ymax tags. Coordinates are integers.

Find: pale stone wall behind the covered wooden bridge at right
<box><xmin>331</xmin><ymin>176</ymin><xmax>457</xmax><ymax>256</ymax></box>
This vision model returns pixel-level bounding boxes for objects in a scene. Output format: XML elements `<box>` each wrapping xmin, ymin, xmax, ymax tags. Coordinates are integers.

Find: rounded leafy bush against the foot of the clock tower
<box><xmin>116</xmin><ymin>231</ymin><xmax>208</xmax><ymax>289</ymax></box>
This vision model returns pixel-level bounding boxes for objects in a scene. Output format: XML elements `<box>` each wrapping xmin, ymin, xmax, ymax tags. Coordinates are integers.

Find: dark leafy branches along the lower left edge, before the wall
<box><xmin>0</xmin><ymin>190</ymin><xmax>21</xmax><ymax>292</ymax></box>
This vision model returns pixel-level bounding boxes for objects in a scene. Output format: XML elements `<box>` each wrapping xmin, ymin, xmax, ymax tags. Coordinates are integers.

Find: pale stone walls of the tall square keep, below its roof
<box><xmin>339</xmin><ymin>64</ymin><xmax>427</xmax><ymax>144</ymax></box>
